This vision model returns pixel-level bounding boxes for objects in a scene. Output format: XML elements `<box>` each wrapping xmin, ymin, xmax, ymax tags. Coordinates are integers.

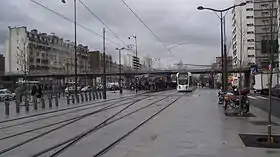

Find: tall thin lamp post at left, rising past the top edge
<box><xmin>61</xmin><ymin>0</ymin><xmax>78</xmax><ymax>96</ymax></box>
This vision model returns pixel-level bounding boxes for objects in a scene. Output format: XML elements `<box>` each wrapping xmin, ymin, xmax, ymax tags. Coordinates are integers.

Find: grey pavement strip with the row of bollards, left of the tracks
<box><xmin>0</xmin><ymin>90</ymin><xmax>140</xmax><ymax>121</ymax></box>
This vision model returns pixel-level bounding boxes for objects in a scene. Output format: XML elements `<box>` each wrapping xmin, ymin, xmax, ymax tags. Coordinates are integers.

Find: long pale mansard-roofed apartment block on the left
<box><xmin>4</xmin><ymin>27</ymin><xmax>90</xmax><ymax>74</ymax></box>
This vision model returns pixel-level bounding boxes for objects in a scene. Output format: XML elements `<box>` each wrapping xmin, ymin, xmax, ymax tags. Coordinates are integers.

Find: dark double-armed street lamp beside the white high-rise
<box><xmin>197</xmin><ymin>2</ymin><xmax>246</xmax><ymax>90</ymax></box>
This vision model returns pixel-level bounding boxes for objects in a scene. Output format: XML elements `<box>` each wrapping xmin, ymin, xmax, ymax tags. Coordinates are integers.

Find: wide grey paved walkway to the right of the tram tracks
<box><xmin>104</xmin><ymin>89</ymin><xmax>280</xmax><ymax>157</ymax></box>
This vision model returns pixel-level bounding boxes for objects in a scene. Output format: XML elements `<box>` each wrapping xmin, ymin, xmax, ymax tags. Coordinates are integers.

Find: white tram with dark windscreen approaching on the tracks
<box><xmin>176</xmin><ymin>72</ymin><xmax>193</xmax><ymax>92</ymax></box>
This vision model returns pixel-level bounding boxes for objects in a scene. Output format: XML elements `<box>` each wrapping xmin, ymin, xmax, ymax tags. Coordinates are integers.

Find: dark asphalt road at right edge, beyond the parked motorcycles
<box><xmin>249</xmin><ymin>95</ymin><xmax>280</xmax><ymax>118</ymax></box>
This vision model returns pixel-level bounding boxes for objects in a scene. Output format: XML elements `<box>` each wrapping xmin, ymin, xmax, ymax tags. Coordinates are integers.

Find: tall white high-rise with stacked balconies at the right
<box><xmin>232</xmin><ymin>0</ymin><xmax>278</xmax><ymax>68</ymax></box>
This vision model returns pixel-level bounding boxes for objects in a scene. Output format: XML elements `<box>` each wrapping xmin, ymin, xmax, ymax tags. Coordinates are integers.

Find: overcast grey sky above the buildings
<box><xmin>0</xmin><ymin>0</ymin><xmax>233</xmax><ymax>66</ymax></box>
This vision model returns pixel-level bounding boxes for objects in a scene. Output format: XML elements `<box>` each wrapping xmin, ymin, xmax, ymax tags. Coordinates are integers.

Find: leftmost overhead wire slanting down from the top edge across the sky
<box><xmin>30</xmin><ymin>0</ymin><xmax>120</xmax><ymax>46</ymax></box>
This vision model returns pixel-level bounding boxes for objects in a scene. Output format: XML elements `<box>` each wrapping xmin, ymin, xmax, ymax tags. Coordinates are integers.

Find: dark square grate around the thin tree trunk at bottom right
<box><xmin>239</xmin><ymin>134</ymin><xmax>280</xmax><ymax>149</ymax></box>
